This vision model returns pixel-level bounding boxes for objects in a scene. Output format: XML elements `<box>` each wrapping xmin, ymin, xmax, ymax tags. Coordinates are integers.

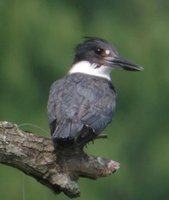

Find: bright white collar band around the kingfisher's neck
<box><xmin>69</xmin><ymin>61</ymin><xmax>112</xmax><ymax>80</ymax></box>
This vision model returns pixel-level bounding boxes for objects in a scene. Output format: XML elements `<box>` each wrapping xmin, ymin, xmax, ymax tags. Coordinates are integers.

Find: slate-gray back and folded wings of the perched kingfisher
<box><xmin>48</xmin><ymin>76</ymin><xmax>115</xmax><ymax>139</ymax></box>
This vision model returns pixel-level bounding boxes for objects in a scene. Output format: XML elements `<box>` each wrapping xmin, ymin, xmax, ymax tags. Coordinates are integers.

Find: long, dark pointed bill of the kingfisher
<box><xmin>106</xmin><ymin>57</ymin><xmax>144</xmax><ymax>71</ymax></box>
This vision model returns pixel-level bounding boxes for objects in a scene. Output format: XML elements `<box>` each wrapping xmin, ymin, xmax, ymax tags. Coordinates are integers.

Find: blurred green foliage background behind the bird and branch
<box><xmin>0</xmin><ymin>0</ymin><xmax>169</xmax><ymax>200</ymax></box>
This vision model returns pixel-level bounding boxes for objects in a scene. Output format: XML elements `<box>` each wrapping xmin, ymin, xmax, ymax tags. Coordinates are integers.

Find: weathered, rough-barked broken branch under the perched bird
<box><xmin>0</xmin><ymin>121</ymin><xmax>119</xmax><ymax>197</ymax></box>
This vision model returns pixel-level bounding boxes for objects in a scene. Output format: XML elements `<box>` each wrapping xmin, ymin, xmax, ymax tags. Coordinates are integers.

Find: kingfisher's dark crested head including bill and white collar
<box><xmin>70</xmin><ymin>37</ymin><xmax>143</xmax><ymax>77</ymax></box>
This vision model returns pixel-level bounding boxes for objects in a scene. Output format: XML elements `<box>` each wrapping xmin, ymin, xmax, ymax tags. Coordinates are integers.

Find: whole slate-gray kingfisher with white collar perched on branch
<box><xmin>47</xmin><ymin>37</ymin><xmax>143</xmax><ymax>145</ymax></box>
